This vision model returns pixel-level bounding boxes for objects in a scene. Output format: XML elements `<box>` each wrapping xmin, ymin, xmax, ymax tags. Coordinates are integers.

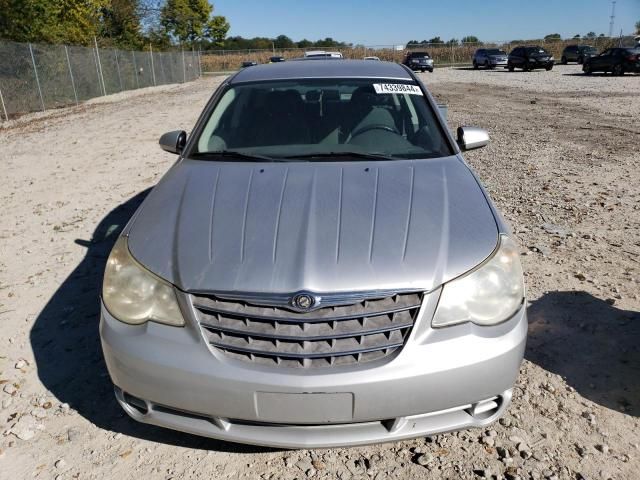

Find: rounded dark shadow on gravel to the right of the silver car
<box><xmin>525</xmin><ymin>291</ymin><xmax>640</xmax><ymax>417</ymax></box>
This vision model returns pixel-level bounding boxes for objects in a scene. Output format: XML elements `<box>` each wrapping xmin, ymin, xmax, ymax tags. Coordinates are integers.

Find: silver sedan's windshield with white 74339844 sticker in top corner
<box><xmin>193</xmin><ymin>79</ymin><xmax>453</xmax><ymax>160</ymax></box>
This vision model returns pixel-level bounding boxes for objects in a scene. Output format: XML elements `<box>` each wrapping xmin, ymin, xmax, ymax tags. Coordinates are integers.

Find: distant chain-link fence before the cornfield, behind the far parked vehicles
<box><xmin>201</xmin><ymin>37</ymin><xmax>633</xmax><ymax>73</ymax></box>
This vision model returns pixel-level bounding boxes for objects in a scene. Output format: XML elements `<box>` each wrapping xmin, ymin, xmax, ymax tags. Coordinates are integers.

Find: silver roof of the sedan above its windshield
<box><xmin>229</xmin><ymin>60</ymin><xmax>413</xmax><ymax>84</ymax></box>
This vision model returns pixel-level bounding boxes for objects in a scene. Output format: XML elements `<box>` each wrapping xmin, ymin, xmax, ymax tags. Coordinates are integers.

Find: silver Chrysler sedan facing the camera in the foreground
<box><xmin>101</xmin><ymin>60</ymin><xmax>527</xmax><ymax>448</ymax></box>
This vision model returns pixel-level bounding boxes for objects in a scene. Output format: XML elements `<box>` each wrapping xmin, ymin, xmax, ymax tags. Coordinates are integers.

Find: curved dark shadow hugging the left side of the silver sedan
<box><xmin>30</xmin><ymin>189</ymin><xmax>270</xmax><ymax>453</ymax></box>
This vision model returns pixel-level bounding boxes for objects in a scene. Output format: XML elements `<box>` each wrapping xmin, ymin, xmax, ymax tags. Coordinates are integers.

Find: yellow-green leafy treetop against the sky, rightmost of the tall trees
<box><xmin>160</xmin><ymin>0</ymin><xmax>229</xmax><ymax>45</ymax></box>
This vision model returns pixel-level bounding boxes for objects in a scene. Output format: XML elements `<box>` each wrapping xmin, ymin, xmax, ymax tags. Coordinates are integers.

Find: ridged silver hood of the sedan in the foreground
<box><xmin>128</xmin><ymin>157</ymin><xmax>498</xmax><ymax>293</ymax></box>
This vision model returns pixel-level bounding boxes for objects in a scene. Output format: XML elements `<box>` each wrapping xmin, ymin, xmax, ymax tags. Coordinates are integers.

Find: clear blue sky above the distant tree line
<box><xmin>211</xmin><ymin>0</ymin><xmax>640</xmax><ymax>45</ymax></box>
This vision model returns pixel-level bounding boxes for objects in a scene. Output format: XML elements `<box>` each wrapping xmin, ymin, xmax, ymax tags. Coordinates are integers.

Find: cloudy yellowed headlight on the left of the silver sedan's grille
<box><xmin>102</xmin><ymin>237</ymin><xmax>184</xmax><ymax>326</ymax></box>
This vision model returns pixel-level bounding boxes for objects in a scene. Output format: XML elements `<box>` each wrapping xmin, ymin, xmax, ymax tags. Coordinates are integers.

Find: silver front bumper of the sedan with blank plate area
<box><xmin>100</xmin><ymin>293</ymin><xmax>527</xmax><ymax>448</ymax></box>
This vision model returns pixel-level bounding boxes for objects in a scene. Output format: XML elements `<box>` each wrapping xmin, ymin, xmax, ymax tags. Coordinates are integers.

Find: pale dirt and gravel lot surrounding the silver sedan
<box><xmin>0</xmin><ymin>66</ymin><xmax>640</xmax><ymax>480</ymax></box>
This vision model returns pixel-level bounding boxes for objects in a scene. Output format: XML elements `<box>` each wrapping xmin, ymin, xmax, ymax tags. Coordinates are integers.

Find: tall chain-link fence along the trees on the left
<box><xmin>0</xmin><ymin>40</ymin><xmax>201</xmax><ymax>120</ymax></box>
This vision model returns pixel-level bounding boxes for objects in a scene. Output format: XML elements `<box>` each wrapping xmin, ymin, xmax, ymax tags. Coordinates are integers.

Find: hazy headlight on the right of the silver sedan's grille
<box><xmin>431</xmin><ymin>235</ymin><xmax>524</xmax><ymax>327</ymax></box>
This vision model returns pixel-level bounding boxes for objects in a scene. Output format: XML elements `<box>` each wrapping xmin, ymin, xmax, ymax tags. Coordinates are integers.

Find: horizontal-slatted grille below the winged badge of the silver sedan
<box><xmin>191</xmin><ymin>292</ymin><xmax>423</xmax><ymax>367</ymax></box>
